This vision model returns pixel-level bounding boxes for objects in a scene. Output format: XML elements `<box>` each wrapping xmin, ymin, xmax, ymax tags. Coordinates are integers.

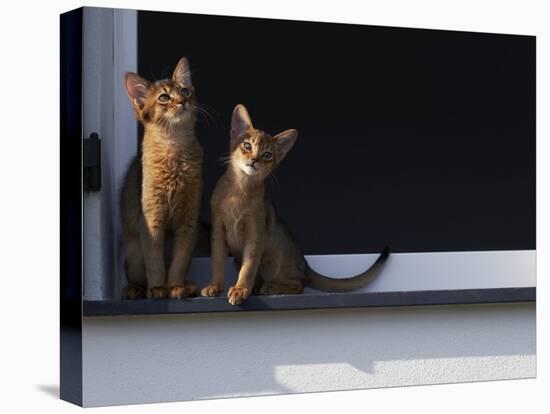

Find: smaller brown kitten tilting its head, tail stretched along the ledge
<box><xmin>201</xmin><ymin>105</ymin><xmax>389</xmax><ymax>305</ymax></box>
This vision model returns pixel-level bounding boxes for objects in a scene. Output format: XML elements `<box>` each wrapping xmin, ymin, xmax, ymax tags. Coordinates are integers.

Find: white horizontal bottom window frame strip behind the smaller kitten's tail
<box><xmin>184</xmin><ymin>250</ymin><xmax>536</xmax><ymax>294</ymax></box>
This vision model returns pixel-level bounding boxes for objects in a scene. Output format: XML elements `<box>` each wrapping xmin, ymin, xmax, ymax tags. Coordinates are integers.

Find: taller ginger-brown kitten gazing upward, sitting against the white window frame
<box><xmin>121</xmin><ymin>58</ymin><xmax>202</xmax><ymax>299</ymax></box>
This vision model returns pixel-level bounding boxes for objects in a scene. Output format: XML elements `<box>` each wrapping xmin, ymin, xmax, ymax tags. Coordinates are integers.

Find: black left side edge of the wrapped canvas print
<box><xmin>59</xmin><ymin>8</ymin><xmax>83</xmax><ymax>406</ymax></box>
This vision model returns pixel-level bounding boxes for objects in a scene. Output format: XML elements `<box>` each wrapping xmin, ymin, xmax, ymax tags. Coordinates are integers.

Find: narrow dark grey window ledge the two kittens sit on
<box><xmin>83</xmin><ymin>287</ymin><xmax>536</xmax><ymax>317</ymax></box>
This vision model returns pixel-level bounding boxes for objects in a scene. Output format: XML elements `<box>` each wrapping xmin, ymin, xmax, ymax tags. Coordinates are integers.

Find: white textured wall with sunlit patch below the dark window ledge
<box><xmin>82</xmin><ymin>304</ymin><xmax>536</xmax><ymax>406</ymax></box>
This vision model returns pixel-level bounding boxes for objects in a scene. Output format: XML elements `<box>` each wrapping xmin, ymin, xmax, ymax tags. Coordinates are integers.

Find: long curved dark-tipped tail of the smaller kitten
<box><xmin>306</xmin><ymin>247</ymin><xmax>390</xmax><ymax>293</ymax></box>
